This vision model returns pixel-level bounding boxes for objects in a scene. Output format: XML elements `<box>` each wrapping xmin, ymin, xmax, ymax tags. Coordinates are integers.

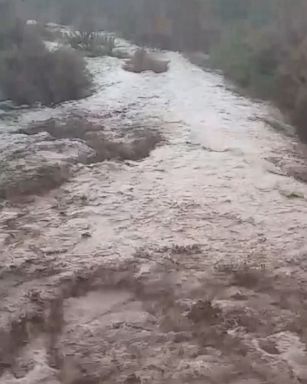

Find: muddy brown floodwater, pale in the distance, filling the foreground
<box><xmin>0</xmin><ymin>48</ymin><xmax>307</xmax><ymax>384</ymax></box>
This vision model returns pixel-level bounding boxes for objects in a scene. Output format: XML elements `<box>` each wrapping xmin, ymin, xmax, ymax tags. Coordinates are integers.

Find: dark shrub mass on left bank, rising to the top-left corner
<box><xmin>0</xmin><ymin>4</ymin><xmax>91</xmax><ymax>105</ymax></box>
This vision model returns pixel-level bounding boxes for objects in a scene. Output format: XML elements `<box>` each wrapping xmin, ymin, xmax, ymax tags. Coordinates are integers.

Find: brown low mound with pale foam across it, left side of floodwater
<box><xmin>0</xmin><ymin>117</ymin><xmax>163</xmax><ymax>199</ymax></box>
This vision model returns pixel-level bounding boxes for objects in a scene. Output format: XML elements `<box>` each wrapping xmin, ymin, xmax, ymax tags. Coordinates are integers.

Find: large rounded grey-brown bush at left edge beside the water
<box><xmin>0</xmin><ymin>38</ymin><xmax>91</xmax><ymax>105</ymax></box>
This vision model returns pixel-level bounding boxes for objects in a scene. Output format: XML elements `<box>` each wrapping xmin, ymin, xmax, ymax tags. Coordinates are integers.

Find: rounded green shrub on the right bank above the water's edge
<box><xmin>210</xmin><ymin>26</ymin><xmax>281</xmax><ymax>98</ymax></box>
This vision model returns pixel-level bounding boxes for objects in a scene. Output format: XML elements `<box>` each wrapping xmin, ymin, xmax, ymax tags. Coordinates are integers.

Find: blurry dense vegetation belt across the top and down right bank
<box><xmin>0</xmin><ymin>0</ymin><xmax>307</xmax><ymax>140</ymax></box>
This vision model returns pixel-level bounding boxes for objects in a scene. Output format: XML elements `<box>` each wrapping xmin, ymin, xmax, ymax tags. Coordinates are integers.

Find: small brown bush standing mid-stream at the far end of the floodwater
<box><xmin>123</xmin><ymin>49</ymin><xmax>169</xmax><ymax>73</ymax></box>
